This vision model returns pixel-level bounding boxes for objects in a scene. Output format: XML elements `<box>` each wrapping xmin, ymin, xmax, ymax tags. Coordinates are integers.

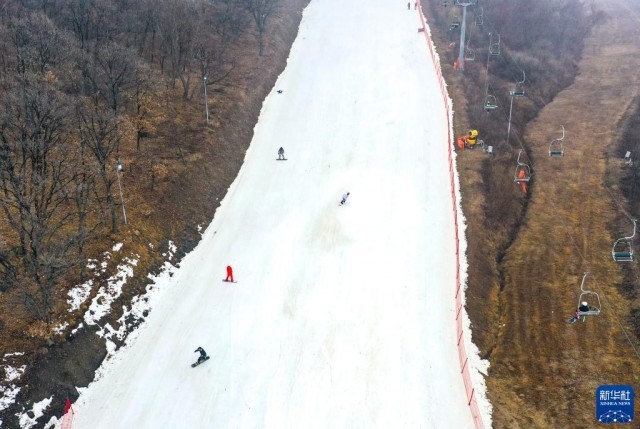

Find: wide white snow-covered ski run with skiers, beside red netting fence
<box><xmin>74</xmin><ymin>0</ymin><xmax>488</xmax><ymax>429</ymax></box>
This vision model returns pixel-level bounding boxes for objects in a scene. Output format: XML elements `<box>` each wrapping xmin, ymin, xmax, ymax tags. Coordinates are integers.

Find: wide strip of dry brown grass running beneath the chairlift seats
<box><xmin>488</xmin><ymin>0</ymin><xmax>640</xmax><ymax>428</ymax></box>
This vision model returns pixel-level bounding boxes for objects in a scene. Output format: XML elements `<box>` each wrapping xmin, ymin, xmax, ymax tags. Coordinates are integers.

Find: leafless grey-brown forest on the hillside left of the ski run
<box><xmin>0</xmin><ymin>0</ymin><xmax>278</xmax><ymax>332</ymax></box>
